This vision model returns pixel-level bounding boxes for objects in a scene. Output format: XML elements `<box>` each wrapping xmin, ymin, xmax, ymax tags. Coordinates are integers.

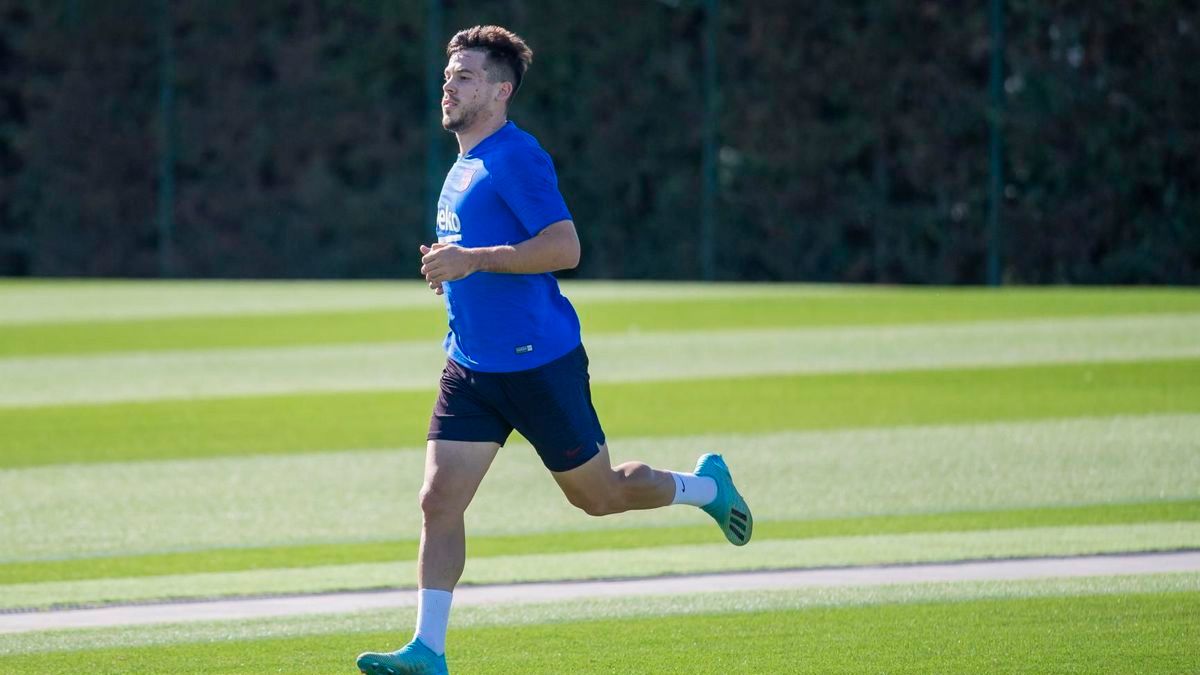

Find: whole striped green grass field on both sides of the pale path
<box><xmin>0</xmin><ymin>281</ymin><xmax>1200</xmax><ymax>673</ymax></box>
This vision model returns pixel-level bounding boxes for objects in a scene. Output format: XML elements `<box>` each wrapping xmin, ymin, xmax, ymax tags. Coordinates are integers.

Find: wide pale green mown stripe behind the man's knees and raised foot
<box><xmin>0</xmin><ymin>414</ymin><xmax>1200</xmax><ymax>562</ymax></box>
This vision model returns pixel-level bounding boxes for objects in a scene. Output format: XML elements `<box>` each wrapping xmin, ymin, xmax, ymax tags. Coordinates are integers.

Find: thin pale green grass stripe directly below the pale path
<box><xmin>0</xmin><ymin>573</ymin><xmax>1200</xmax><ymax>653</ymax></box>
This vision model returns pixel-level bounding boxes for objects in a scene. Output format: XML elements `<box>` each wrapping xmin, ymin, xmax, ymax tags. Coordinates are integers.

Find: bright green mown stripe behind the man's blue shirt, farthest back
<box><xmin>0</xmin><ymin>288</ymin><xmax>1200</xmax><ymax>357</ymax></box>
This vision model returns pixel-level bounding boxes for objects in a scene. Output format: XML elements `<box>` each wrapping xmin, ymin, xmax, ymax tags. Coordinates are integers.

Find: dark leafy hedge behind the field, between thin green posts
<box><xmin>0</xmin><ymin>0</ymin><xmax>1200</xmax><ymax>283</ymax></box>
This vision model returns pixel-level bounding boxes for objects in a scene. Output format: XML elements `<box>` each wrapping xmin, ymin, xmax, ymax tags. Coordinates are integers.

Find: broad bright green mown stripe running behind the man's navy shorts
<box><xmin>0</xmin><ymin>360</ymin><xmax>1200</xmax><ymax>467</ymax></box>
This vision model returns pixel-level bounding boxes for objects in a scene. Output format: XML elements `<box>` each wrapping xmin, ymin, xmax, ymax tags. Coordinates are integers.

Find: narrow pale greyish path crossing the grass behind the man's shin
<box><xmin>0</xmin><ymin>551</ymin><xmax>1200</xmax><ymax>634</ymax></box>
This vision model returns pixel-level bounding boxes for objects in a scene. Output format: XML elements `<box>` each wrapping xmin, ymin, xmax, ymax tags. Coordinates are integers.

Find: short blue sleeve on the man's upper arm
<box><xmin>488</xmin><ymin>147</ymin><xmax>571</xmax><ymax>235</ymax></box>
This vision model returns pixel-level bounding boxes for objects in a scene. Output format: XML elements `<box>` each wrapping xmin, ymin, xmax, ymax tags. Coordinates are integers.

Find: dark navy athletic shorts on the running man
<box><xmin>426</xmin><ymin>345</ymin><xmax>605</xmax><ymax>471</ymax></box>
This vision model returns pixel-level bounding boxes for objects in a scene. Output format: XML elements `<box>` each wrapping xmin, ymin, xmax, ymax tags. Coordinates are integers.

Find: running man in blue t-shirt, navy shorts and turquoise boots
<box><xmin>358</xmin><ymin>26</ymin><xmax>754</xmax><ymax>675</ymax></box>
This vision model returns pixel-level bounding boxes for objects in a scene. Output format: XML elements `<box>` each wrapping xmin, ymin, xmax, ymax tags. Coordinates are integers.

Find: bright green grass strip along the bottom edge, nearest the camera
<box><xmin>0</xmin><ymin>592</ymin><xmax>1200</xmax><ymax>675</ymax></box>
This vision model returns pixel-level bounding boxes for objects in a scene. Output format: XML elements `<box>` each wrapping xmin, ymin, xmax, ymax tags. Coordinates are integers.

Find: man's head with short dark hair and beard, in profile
<box><xmin>442</xmin><ymin>25</ymin><xmax>533</xmax><ymax>131</ymax></box>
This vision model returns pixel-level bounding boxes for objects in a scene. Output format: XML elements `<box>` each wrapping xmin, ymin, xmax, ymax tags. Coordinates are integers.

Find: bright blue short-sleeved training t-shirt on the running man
<box><xmin>437</xmin><ymin>121</ymin><xmax>580</xmax><ymax>372</ymax></box>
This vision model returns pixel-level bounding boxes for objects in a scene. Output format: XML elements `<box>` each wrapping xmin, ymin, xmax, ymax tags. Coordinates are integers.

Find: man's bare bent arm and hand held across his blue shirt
<box><xmin>421</xmin><ymin>220</ymin><xmax>580</xmax><ymax>294</ymax></box>
